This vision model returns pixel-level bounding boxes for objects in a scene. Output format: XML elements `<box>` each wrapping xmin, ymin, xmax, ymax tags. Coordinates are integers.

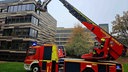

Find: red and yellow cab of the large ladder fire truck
<box><xmin>24</xmin><ymin>44</ymin><xmax>58</xmax><ymax>72</ymax></box>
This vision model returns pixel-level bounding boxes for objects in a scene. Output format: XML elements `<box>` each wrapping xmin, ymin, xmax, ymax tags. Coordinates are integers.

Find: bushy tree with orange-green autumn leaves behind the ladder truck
<box><xmin>65</xmin><ymin>25</ymin><xmax>93</xmax><ymax>57</ymax></box>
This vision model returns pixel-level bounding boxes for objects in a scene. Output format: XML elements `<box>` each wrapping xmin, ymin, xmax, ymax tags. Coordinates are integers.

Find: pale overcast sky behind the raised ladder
<box><xmin>48</xmin><ymin>0</ymin><xmax>128</xmax><ymax>30</ymax></box>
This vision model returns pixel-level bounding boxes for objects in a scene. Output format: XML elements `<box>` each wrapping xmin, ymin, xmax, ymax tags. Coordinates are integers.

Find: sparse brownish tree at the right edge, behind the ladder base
<box><xmin>111</xmin><ymin>12</ymin><xmax>128</xmax><ymax>46</ymax></box>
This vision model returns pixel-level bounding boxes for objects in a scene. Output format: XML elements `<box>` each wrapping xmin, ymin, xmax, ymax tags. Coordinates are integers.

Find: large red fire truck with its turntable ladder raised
<box><xmin>24</xmin><ymin>0</ymin><xmax>127</xmax><ymax>72</ymax></box>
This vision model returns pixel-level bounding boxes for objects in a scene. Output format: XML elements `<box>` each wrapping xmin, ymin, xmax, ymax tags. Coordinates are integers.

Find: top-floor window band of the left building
<box><xmin>8</xmin><ymin>4</ymin><xmax>35</xmax><ymax>12</ymax></box>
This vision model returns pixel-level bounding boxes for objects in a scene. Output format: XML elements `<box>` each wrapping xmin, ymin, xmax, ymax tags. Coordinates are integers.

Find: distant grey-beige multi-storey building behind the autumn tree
<box><xmin>55</xmin><ymin>27</ymin><xmax>95</xmax><ymax>46</ymax></box>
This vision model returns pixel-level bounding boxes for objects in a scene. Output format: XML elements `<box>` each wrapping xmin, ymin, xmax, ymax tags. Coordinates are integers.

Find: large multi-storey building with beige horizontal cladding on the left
<box><xmin>0</xmin><ymin>0</ymin><xmax>57</xmax><ymax>60</ymax></box>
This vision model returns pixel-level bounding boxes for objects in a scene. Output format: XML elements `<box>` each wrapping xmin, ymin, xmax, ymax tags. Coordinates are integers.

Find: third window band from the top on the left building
<box><xmin>3</xmin><ymin>28</ymin><xmax>38</xmax><ymax>38</ymax></box>
